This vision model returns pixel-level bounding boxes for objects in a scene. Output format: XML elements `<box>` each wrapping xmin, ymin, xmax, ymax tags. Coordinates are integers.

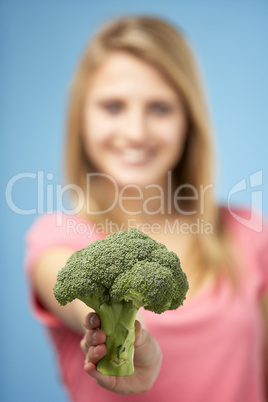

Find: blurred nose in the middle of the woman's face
<box><xmin>123</xmin><ymin>105</ymin><xmax>147</xmax><ymax>144</ymax></box>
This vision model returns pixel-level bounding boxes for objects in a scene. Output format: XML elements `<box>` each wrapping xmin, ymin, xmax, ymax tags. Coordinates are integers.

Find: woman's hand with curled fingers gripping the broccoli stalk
<box><xmin>81</xmin><ymin>313</ymin><xmax>162</xmax><ymax>394</ymax></box>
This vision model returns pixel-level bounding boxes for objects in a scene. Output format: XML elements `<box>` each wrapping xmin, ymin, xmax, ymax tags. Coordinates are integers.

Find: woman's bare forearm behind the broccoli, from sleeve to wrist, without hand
<box><xmin>32</xmin><ymin>248</ymin><xmax>92</xmax><ymax>334</ymax></box>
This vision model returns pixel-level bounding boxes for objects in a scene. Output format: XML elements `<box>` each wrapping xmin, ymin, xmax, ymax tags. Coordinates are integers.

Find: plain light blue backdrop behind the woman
<box><xmin>0</xmin><ymin>0</ymin><xmax>268</xmax><ymax>402</ymax></box>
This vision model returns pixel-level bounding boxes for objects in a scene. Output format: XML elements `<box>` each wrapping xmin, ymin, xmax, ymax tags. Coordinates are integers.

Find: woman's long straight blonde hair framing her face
<box><xmin>66</xmin><ymin>16</ymin><xmax>237</xmax><ymax>284</ymax></box>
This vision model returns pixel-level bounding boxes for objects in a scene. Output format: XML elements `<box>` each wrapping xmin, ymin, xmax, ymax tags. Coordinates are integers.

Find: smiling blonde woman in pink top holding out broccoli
<box><xmin>26</xmin><ymin>17</ymin><xmax>268</xmax><ymax>402</ymax></box>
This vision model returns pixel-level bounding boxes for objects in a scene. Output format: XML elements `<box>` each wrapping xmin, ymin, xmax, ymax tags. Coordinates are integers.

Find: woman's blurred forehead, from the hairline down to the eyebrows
<box><xmin>89</xmin><ymin>51</ymin><xmax>177</xmax><ymax>97</ymax></box>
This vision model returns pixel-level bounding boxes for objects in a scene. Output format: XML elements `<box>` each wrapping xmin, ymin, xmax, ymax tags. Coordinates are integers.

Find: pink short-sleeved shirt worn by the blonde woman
<box><xmin>25</xmin><ymin>210</ymin><xmax>268</xmax><ymax>402</ymax></box>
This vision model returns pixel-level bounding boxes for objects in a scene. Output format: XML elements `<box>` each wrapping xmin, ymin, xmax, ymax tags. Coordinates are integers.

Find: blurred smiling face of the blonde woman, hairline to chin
<box><xmin>83</xmin><ymin>52</ymin><xmax>187</xmax><ymax>187</ymax></box>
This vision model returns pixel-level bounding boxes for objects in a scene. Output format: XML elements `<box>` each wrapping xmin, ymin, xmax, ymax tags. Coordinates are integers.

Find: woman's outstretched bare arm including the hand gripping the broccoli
<box><xmin>33</xmin><ymin>245</ymin><xmax>161</xmax><ymax>394</ymax></box>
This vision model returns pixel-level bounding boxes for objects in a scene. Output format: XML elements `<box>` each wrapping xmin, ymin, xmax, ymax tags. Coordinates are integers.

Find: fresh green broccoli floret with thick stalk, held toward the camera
<box><xmin>54</xmin><ymin>229</ymin><xmax>188</xmax><ymax>376</ymax></box>
